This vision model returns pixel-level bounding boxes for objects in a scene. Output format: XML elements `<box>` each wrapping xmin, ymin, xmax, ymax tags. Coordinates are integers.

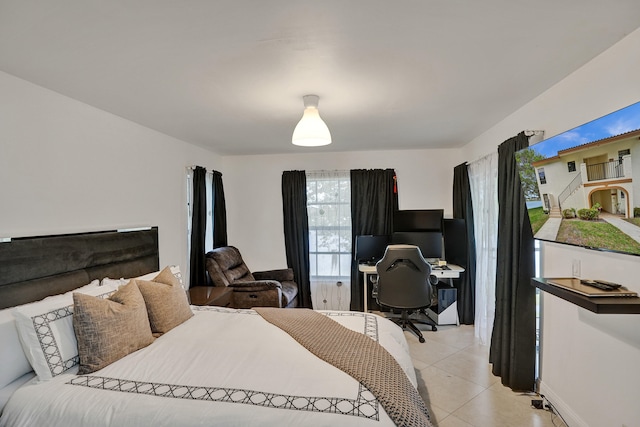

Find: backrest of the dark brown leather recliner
<box><xmin>205</xmin><ymin>246</ymin><xmax>255</xmax><ymax>286</ymax></box>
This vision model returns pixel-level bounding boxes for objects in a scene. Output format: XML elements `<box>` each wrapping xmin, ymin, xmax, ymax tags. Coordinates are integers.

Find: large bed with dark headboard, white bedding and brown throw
<box><xmin>0</xmin><ymin>228</ymin><xmax>430</xmax><ymax>426</ymax></box>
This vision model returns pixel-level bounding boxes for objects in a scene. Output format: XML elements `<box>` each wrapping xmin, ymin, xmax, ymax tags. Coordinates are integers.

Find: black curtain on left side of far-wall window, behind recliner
<box><xmin>282</xmin><ymin>171</ymin><xmax>311</xmax><ymax>308</ymax></box>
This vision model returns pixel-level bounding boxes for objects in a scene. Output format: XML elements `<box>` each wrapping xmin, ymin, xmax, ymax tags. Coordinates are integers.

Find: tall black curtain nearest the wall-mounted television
<box><xmin>489</xmin><ymin>132</ymin><xmax>536</xmax><ymax>391</ymax></box>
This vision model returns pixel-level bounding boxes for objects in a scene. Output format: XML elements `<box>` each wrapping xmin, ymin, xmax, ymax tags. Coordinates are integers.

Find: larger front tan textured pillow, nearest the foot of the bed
<box><xmin>73</xmin><ymin>281</ymin><xmax>154</xmax><ymax>375</ymax></box>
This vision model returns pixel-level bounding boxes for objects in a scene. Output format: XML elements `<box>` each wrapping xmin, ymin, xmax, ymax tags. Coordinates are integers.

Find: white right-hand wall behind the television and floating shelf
<box><xmin>465</xmin><ymin>30</ymin><xmax>640</xmax><ymax>427</ymax></box>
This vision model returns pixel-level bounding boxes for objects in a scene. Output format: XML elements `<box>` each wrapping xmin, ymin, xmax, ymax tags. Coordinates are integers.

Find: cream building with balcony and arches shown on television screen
<box><xmin>533</xmin><ymin>129</ymin><xmax>640</xmax><ymax>218</ymax></box>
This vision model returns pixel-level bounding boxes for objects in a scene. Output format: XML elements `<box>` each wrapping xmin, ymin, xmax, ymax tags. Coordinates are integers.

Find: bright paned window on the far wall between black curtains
<box><xmin>307</xmin><ymin>171</ymin><xmax>351</xmax><ymax>283</ymax></box>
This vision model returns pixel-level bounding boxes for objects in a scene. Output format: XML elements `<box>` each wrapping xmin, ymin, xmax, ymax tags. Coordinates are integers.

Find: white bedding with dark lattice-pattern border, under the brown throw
<box><xmin>0</xmin><ymin>306</ymin><xmax>416</xmax><ymax>427</ymax></box>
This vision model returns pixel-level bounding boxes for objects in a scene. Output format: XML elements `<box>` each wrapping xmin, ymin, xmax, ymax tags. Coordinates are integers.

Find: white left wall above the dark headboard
<box><xmin>0</xmin><ymin>72</ymin><xmax>220</xmax><ymax>271</ymax></box>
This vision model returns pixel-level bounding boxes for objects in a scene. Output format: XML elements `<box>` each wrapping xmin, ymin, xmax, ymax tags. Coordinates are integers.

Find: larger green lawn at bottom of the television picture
<box><xmin>556</xmin><ymin>219</ymin><xmax>640</xmax><ymax>255</ymax></box>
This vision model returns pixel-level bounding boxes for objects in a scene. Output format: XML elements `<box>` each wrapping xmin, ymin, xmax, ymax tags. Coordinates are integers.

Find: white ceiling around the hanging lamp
<box><xmin>0</xmin><ymin>0</ymin><xmax>640</xmax><ymax>155</ymax></box>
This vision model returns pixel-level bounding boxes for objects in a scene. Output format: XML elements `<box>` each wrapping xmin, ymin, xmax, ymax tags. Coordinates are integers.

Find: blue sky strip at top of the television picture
<box><xmin>531</xmin><ymin>102</ymin><xmax>640</xmax><ymax>157</ymax></box>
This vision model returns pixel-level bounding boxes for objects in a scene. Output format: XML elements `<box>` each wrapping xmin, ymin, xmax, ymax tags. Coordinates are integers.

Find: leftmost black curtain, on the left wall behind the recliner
<box><xmin>189</xmin><ymin>166</ymin><xmax>207</xmax><ymax>287</ymax></box>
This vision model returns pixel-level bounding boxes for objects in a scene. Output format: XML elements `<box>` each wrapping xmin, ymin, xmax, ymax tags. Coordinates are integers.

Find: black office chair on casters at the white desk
<box><xmin>376</xmin><ymin>245</ymin><xmax>438</xmax><ymax>343</ymax></box>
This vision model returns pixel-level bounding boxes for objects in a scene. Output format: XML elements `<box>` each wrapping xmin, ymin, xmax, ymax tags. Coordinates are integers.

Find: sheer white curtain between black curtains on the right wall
<box><xmin>468</xmin><ymin>152</ymin><xmax>498</xmax><ymax>345</ymax></box>
